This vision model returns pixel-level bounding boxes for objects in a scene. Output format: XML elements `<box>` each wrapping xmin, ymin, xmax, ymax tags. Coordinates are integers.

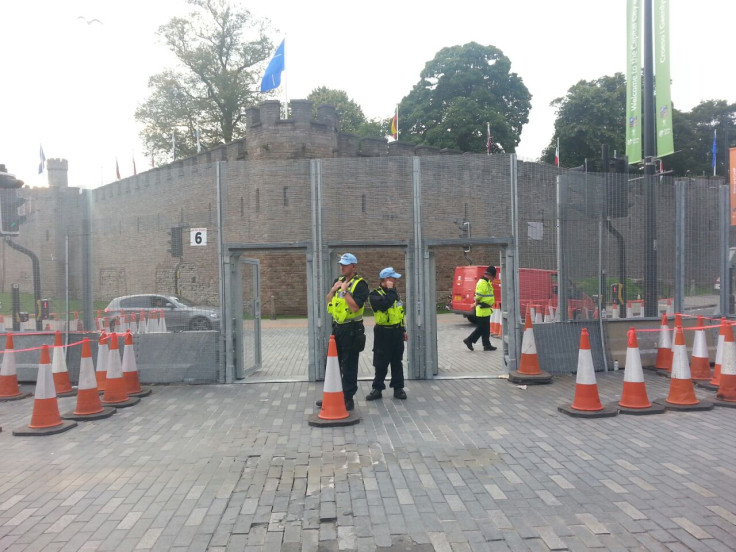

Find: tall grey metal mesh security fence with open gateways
<box><xmin>0</xmin><ymin>152</ymin><xmax>733</xmax><ymax>382</ymax></box>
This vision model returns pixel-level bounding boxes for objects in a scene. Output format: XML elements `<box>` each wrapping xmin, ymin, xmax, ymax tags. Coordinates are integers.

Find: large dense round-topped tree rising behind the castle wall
<box><xmin>399</xmin><ymin>42</ymin><xmax>531</xmax><ymax>152</ymax></box>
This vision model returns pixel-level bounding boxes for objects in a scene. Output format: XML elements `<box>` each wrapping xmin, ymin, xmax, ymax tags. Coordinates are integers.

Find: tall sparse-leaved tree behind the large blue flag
<box><xmin>135</xmin><ymin>0</ymin><xmax>273</xmax><ymax>161</ymax></box>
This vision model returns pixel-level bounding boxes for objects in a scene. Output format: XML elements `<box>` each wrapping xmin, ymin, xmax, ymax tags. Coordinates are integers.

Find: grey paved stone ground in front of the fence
<box><xmin>0</xmin><ymin>366</ymin><xmax>736</xmax><ymax>552</ymax></box>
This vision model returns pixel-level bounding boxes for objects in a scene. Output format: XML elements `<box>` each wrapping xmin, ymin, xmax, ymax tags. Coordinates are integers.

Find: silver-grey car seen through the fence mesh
<box><xmin>105</xmin><ymin>294</ymin><xmax>220</xmax><ymax>332</ymax></box>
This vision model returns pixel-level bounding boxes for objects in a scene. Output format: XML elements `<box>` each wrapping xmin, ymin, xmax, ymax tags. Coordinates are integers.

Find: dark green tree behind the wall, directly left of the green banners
<box><xmin>541</xmin><ymin>73</ymin><xmax>626</xmax><ymax>170</ymax></box>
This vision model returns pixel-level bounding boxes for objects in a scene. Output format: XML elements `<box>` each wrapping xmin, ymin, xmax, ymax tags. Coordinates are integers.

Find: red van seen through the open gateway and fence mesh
<box><xmin>450</xmin><ymin>265</ymin><xmax>595</xmax><ymax>322</ymax></box>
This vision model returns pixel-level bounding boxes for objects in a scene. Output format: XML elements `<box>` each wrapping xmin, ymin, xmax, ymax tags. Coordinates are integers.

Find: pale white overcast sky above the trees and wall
<box><xmin>0</xmin><ymin>0</ymin><xmax>736</xmax><ymax>188</ymax></box>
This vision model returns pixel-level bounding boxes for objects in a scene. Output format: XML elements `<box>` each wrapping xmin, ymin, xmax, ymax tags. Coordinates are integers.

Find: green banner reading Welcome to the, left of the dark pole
<box><xmin>626</xmin><ymin>0</ymin><xmax>642</xmax><ymax>164</ymax></box>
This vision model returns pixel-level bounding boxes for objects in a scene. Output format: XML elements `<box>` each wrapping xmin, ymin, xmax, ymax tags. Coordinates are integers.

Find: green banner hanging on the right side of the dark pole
<box><xmin>654</xmin><ymin>0</ymin><xmax>675</xmax><ymax>157</ymax></box>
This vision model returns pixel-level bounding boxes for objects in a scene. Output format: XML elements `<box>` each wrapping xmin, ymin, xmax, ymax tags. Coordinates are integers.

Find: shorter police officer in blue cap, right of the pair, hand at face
<box><xmin>365</xmin><ymin>266</ymin><xmax>407</xmax><ymax>401</ymax></box>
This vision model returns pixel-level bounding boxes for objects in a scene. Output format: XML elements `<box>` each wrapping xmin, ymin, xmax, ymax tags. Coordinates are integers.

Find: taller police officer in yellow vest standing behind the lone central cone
<box><xmin>318</xmin><ymin>253</ymin><xmax>369</xmax><ymax>410</ymax></box>
